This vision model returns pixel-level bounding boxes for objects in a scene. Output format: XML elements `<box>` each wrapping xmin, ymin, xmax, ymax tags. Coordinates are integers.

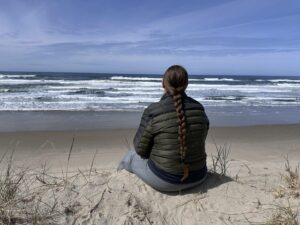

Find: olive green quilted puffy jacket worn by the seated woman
<box><xmin>134</xmin><ymin>94</ymin><xmax>209</xmax><ymax>175</ymax></box>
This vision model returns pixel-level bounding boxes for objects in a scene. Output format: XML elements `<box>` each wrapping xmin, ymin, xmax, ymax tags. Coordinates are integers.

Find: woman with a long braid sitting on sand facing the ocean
<box><xmin>118</xmin><ymin>65</ymin><xmax>209</xmax><ymax>192</ymax></box>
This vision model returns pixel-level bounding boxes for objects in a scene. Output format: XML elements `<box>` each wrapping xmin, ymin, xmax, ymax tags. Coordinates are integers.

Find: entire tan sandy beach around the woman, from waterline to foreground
<box><xmin>0</xmin><ymin>124</ymin><xmax>300</xmax><ymax>225</ymax></box>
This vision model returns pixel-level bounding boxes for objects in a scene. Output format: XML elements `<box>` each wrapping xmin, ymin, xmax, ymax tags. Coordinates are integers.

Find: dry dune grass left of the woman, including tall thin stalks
<box><xmin>0</xmin><ymin>137</ymin><xmax>108</xmax><ymax>225</ymax></box>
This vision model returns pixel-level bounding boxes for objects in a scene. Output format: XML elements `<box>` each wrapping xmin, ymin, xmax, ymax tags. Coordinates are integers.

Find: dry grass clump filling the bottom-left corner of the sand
<box><xmin>0</xmin><ymin>153</ymin><xmax>57</xmax><ymax>225</ymax></box>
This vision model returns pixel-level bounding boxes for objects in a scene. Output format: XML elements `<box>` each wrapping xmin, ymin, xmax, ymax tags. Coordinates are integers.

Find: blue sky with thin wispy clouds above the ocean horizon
<box><xmin>0</xmin><ymin>0</ymin><xmax>300</xmax><ymax>76</ymax></box>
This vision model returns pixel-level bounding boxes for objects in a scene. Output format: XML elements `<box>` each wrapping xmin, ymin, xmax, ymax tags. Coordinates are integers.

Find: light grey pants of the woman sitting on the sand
<box><xmin>118</xmin><ymin>150</ymin><xmax>206</xmax><ymax>192</ymax></box>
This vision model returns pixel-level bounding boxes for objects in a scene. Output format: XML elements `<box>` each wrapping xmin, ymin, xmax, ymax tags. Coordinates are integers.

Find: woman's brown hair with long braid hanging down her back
<box><xmin>163</xmin><ymin>65</ymin><xmax>189</xmax><ymax>181</ymax></box>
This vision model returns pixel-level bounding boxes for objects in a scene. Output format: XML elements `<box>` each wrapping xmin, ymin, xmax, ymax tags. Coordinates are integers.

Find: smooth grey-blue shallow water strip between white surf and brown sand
<box><xmin>0</xmin><ymin>107</ymin><xmax>300</xmax><ymax>132</ymax></box>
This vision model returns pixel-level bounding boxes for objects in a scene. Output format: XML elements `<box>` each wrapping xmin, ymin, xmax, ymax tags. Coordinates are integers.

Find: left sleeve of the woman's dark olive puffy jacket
<box><xmin>133</xmin><ymin>109</ymin><xmax>153</xmax><ymax>159</ymax></box>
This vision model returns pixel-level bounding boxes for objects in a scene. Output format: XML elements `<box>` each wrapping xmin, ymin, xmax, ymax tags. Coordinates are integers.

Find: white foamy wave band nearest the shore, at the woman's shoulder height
<box><xmin>0</xmin><ymin>97</ymin><xmax>300</xmax><ymax>111</ymax></box>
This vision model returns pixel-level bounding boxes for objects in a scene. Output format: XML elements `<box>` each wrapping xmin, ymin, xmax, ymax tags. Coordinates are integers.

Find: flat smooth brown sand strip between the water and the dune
<box><xmin>0</xmin><ymin>124</ymin><xmax>300</xmax><ymax>171</ymax></box>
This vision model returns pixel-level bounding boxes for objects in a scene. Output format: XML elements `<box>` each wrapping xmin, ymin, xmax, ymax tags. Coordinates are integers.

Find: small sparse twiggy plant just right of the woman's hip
<box><xmin>211</xmin><ymin>141</ymin><xmax>231</xmax><ymax>176</ymax></box>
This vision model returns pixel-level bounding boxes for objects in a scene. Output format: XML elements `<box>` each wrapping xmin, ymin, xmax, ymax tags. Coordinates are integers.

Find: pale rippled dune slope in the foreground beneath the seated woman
<box><xmin>28</xmin><ymin>158</ymin><xmax>300</xmax><ymax>225</ymax></box>
